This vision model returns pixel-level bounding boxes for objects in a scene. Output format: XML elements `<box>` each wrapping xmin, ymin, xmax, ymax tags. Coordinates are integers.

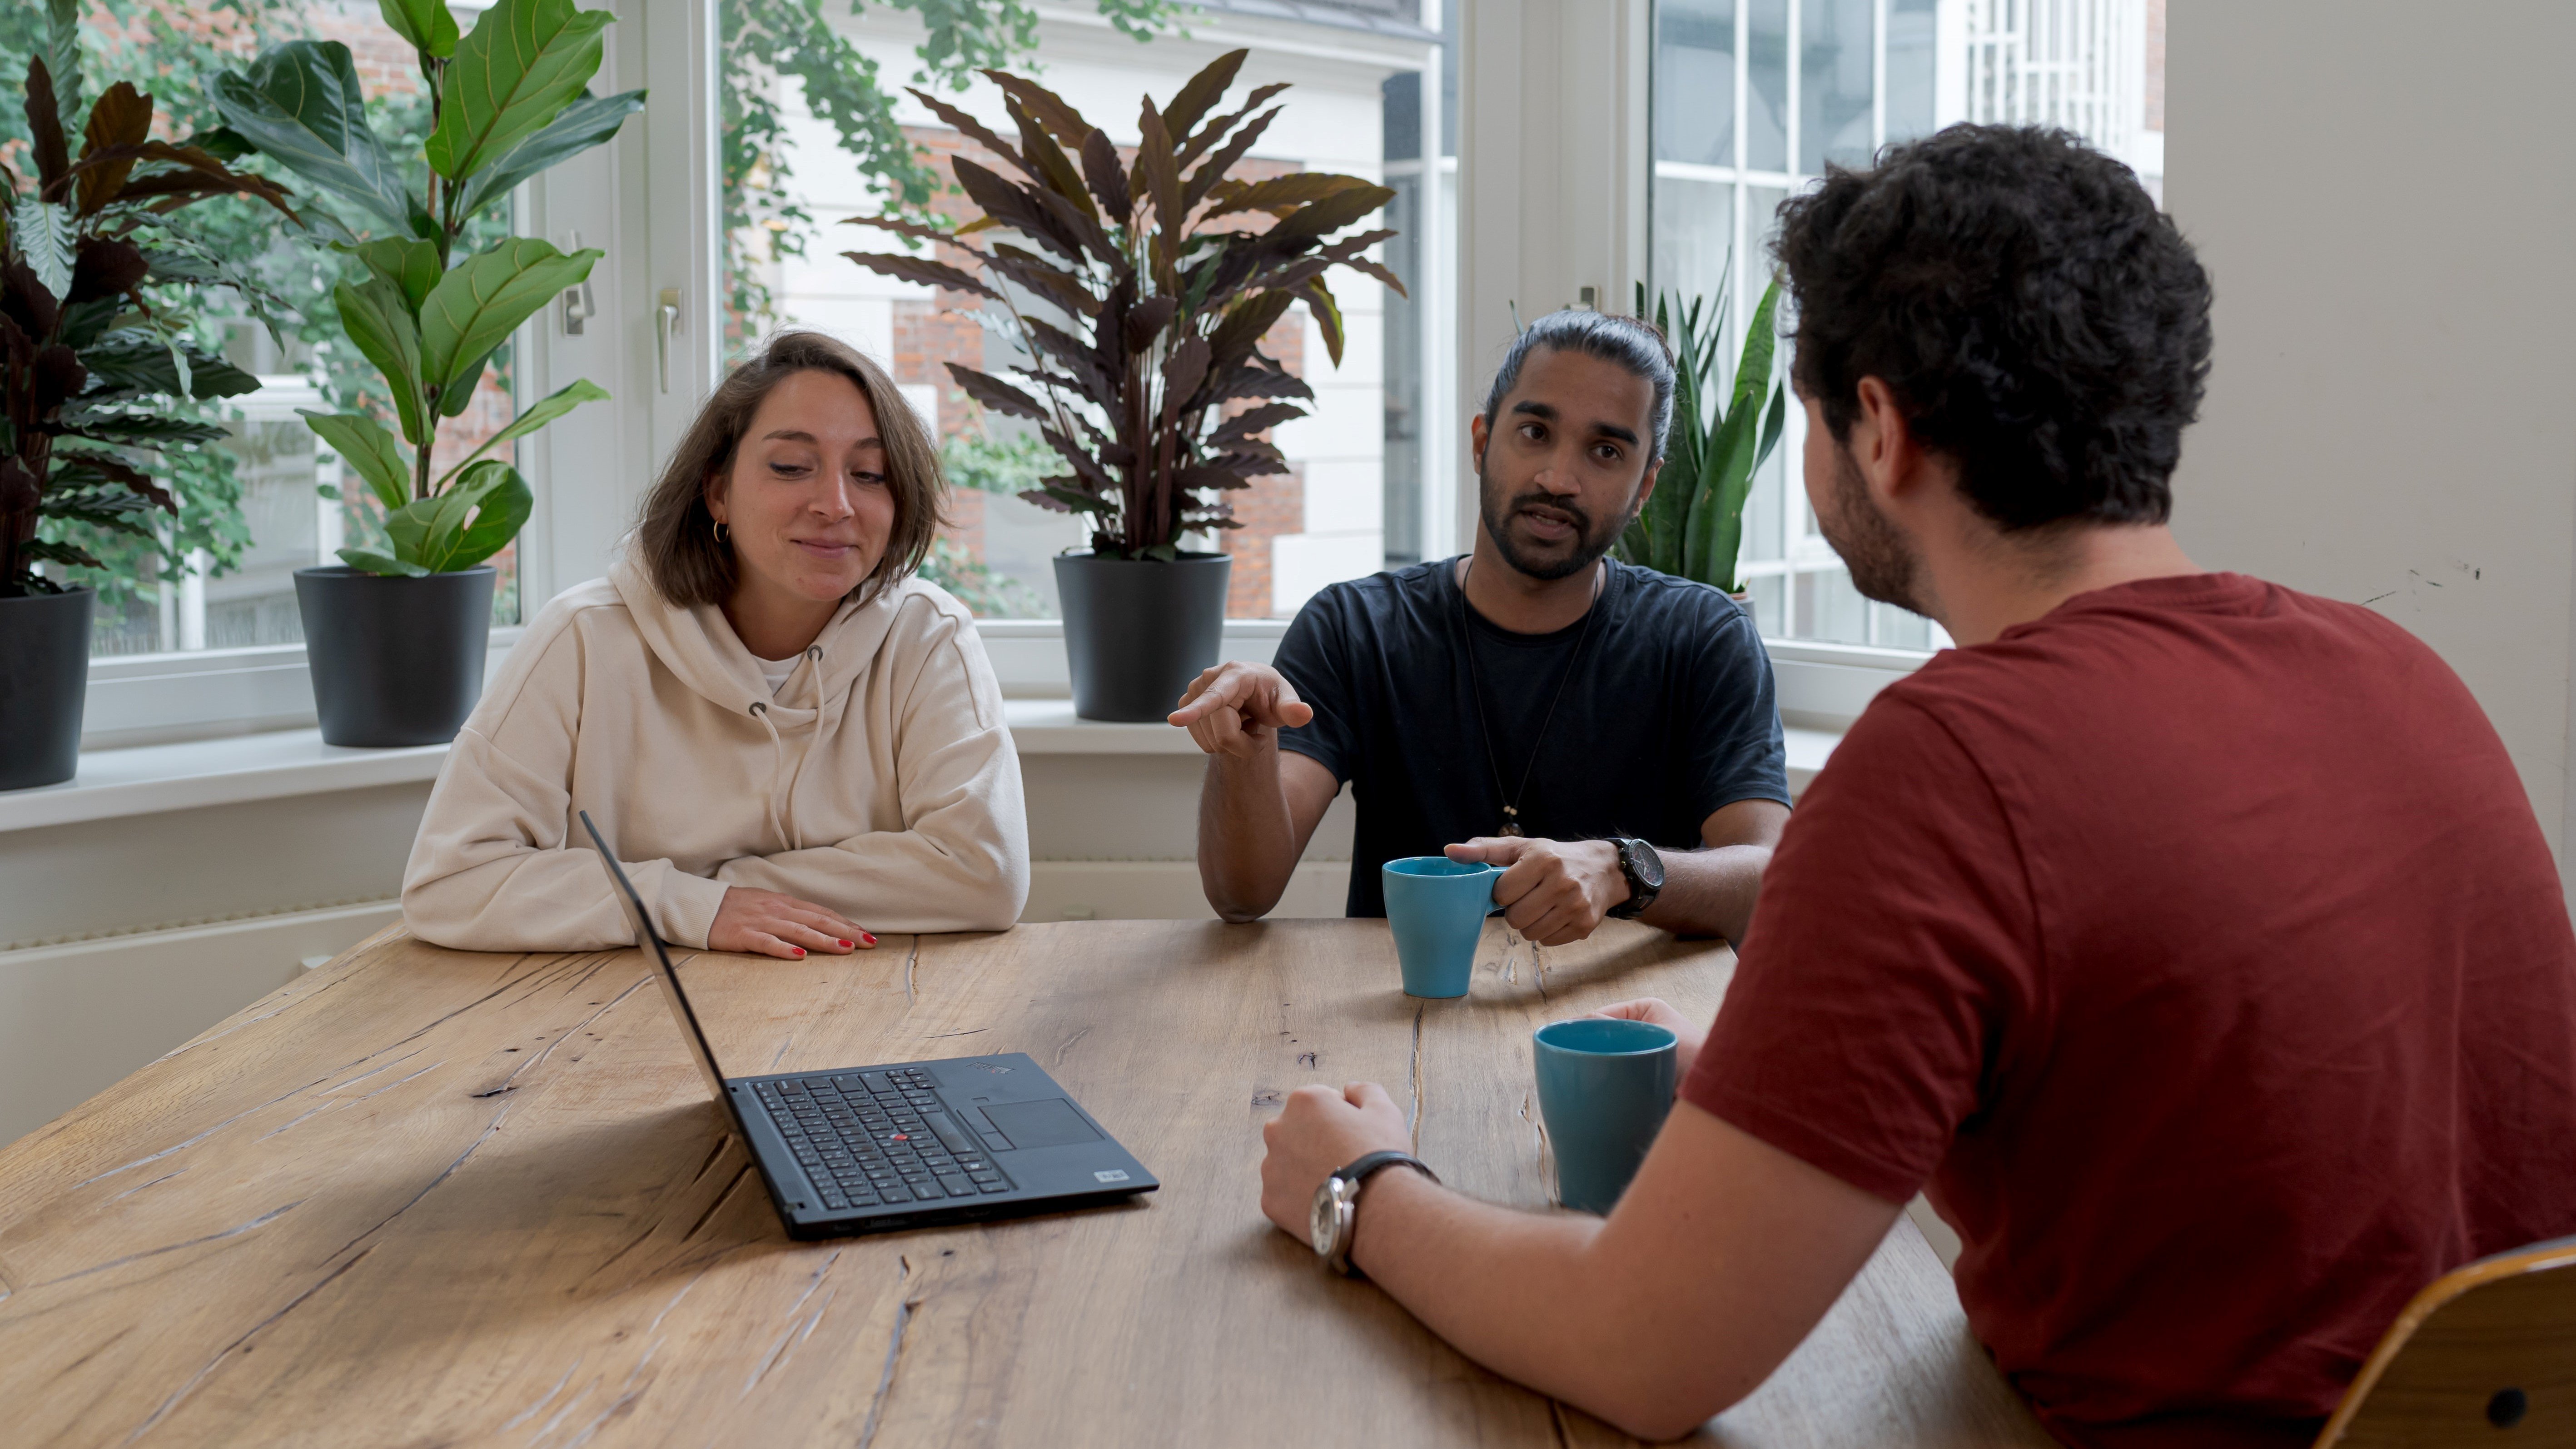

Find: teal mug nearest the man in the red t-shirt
<box><xmin>1535</xmin><ymin>1016</ymin><xmax>1680</xmax><ymax>1212</ymax></box>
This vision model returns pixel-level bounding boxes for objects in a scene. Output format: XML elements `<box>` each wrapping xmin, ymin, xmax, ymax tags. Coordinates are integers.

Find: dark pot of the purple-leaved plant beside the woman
<box><xmin>1056</xmin><ymin>554</ymin><xmax>1234</xmax><ymax>722</ymax></box>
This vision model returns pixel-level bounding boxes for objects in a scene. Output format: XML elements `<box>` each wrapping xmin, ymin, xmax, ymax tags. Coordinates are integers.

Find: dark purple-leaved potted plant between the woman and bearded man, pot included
<box><xmin>845</xmin><ymin>51</ymin><xmax>1404</xmax><ymax>719</ymax></box>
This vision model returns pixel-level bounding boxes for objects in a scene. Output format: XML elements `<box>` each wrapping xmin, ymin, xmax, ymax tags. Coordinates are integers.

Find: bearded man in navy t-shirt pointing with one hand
<box><xmin>1172</xmin><ymin>312</ymin><xmax>1788</xmax><ymax>946</ymax></box>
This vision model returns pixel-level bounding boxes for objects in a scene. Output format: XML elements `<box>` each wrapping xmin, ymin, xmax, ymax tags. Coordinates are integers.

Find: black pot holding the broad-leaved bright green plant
<box><xmin>296</xmin><ymin>565</ymin><xmax>495</xmax><ymax>748</ymax></box>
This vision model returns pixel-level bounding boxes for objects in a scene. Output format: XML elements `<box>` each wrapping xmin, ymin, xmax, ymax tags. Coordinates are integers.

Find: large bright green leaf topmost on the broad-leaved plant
<box><xmin>425</xmin><ymin>0</ymin><xmax>616</xmax><ymax>180</ymax></box>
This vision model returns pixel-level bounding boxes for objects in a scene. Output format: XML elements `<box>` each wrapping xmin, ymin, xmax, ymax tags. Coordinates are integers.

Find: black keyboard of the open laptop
<box><xmin>757</xmin><ymin>1067</ymin><xmax>1010</xmax><ymax>1209</ymax></box>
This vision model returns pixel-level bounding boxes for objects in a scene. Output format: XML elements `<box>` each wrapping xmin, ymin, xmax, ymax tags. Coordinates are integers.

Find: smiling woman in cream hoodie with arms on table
<box><xmin>402</xmin><ymin>333</ymin><xmax>1028</xmax><ymax>956</ymax></box>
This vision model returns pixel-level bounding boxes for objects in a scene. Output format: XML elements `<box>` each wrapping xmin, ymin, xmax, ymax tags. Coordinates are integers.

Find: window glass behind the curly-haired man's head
<box><xmin>1649</xmin><ymin>0</ymin><xmax>2164</xmax><ymax>650</ymax></box>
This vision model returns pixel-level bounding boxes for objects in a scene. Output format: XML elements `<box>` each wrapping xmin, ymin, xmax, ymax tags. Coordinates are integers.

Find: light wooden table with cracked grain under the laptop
<box><xmin>0</xmin><ymin>921</ymin><xmax>2045</xmax><ymax>1449</ymax></box>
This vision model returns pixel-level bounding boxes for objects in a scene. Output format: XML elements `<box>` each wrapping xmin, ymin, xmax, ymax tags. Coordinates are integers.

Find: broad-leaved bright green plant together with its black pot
<box><xmin>214</xmin><ymin>0</ymin><xmax>644</xmax><ymax>745</ymax></box>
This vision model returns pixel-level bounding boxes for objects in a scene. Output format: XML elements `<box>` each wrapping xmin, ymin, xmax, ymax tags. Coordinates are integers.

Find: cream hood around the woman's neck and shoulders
<box><xmin>608</xmin><ymin>559</ymin><xmax>912</xmax><ymax>732</ymax></box>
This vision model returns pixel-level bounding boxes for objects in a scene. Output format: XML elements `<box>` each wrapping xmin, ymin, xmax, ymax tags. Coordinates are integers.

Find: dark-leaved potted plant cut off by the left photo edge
<box><xmin>0</xmin><ymin>0</ymin><xmax>293</xmax><ymax>789</ymax></box>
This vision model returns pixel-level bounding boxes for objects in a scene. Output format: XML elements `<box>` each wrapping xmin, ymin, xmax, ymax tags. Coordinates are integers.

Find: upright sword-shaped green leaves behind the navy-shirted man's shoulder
<box><xmin>1615</xmin><ymin>268</ymin><xmax>1788</xmax><ymax>621</ymax></box>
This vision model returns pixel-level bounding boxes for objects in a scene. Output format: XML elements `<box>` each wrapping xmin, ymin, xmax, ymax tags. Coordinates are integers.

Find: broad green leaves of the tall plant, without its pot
<box><xmin>214</xmin><ymin>0</ymin><xmax>644</xmax><ymax>575</ymax></box>
